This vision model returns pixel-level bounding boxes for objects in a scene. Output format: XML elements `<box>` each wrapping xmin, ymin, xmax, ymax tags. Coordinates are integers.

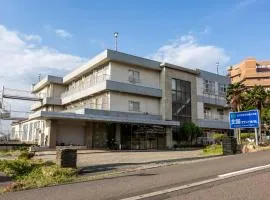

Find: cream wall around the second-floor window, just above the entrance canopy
<box><xmin>110</xmin><ymin>92</ymin><xmax>160</xmax><ymax>115</ymax></box>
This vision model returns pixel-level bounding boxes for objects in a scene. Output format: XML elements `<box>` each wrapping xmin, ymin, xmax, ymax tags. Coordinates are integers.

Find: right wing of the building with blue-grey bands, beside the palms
<box><xmin>197</xmin><ymin>70</ymin><xmax>230</xmax><ymax>137</ymax></box>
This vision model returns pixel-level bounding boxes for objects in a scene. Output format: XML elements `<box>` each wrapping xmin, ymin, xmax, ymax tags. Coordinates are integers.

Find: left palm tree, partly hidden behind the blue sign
<box><xmin>226</xmin><ymin>83</ymin><xmax>247</xmax><ymax>144</ymax></box>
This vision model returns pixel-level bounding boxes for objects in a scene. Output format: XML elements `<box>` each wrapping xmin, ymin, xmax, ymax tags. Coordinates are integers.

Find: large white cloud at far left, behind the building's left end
<box><xmin>0</xmin><ymin>24</ymin><xmax>86</xmax><ymax>128</ymax></box>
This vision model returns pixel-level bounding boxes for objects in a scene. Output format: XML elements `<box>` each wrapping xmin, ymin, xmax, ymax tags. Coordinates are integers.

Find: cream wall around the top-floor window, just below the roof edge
<box><xmin>110</xmin><ymin>62</ymin><xmax>160</xmax><ymax>88</ymax></box>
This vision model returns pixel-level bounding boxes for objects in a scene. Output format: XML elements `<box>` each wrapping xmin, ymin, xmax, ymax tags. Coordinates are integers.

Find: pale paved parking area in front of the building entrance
<box><xmin>36</xmin><ymin>149</ymin><xmax>203</xmax><ymax>167</ymax></box>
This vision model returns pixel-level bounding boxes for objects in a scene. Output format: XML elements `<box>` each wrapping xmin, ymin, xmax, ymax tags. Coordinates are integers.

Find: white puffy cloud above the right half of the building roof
<box><xmin>150</xmin><ymin>34</ymin><xmax>230</xmax><ymax>71</ymax></box>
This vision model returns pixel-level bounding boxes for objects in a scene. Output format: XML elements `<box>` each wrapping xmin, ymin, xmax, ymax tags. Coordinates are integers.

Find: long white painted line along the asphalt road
<box><xmin>121</xmin><ymin>164</ymin><xmax>270</xmax><ymax>200</ymax></box>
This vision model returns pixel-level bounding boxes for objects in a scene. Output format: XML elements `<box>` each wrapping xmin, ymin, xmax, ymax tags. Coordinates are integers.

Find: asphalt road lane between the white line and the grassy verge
<box><xmin>0</xmin><ymin>151</ymin><xmax>270</xmax><ymax>200</ymax></box>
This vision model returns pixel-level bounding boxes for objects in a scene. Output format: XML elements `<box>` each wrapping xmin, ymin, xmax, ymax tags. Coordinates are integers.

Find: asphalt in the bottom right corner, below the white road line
<box><xmin>161</xmin><ymin>170</ymin><xmax>270</xmax><ymax>200</ymax></box>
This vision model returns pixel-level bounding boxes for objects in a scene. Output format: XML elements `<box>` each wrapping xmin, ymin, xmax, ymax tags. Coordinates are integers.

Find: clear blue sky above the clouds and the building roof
<box><xmin>0</xmin><ymin>0</ymin><xmax>270</xmax><ymax>69</ymax></box>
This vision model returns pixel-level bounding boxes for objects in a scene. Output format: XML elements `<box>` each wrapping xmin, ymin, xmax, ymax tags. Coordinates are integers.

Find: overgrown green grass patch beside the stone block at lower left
<box><xmin>0</xmin><ymin>159</ymin><xmax>77</xmax><ymax>192</ymax></box>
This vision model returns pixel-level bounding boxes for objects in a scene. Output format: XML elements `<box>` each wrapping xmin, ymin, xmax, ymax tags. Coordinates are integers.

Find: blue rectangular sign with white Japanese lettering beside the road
<box><xmin>229</xmin><ymin>110</ymin><xmax>260</xmax><ymax>129</ymax></box>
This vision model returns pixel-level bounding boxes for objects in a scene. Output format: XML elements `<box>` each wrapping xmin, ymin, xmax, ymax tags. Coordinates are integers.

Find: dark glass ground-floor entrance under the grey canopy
<box><xmin>121</xmin><ymin>124</ymin><xmax>166</xmax><ymax>150</ymax></box>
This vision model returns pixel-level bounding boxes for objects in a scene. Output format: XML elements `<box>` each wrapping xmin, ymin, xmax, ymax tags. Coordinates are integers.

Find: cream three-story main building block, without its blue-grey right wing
<box><xmin>12</xmin><ymin>50</ymin><xmax>230</xmax><ymax>149</ymax></box>
